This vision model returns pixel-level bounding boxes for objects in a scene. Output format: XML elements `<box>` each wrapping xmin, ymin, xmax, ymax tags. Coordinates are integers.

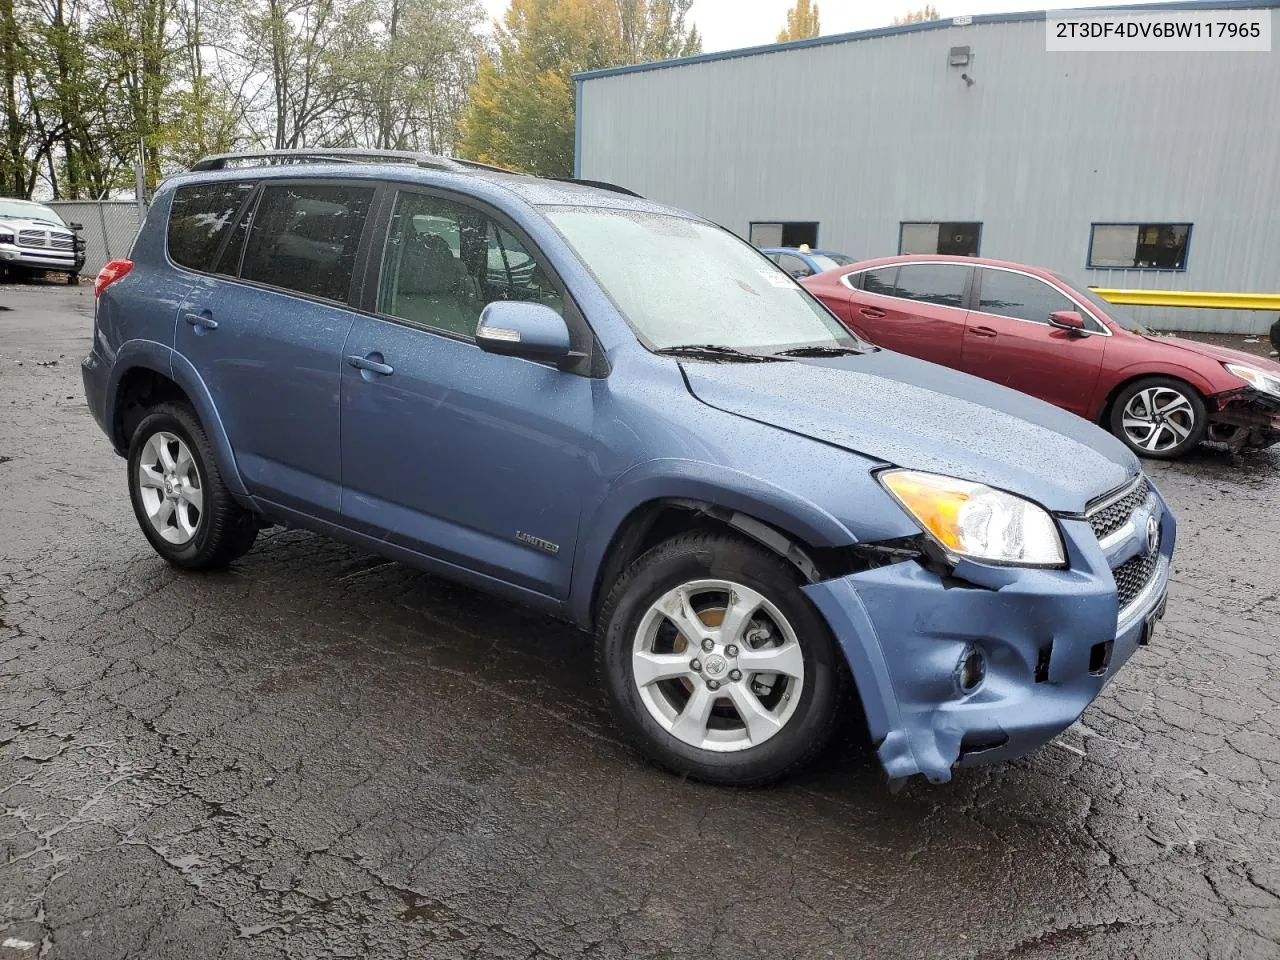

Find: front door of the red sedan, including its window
<box><xmin>961</xmin><ymin>266</ymin><xmax>1107</xmax><ymax>416</ymax></box>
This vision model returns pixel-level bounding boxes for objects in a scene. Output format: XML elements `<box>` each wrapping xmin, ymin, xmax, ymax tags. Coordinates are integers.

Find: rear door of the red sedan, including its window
<box><xmin>850</xmin><ymin>262</ymin><xmax>973</xmax><ymax>367</ymax></box>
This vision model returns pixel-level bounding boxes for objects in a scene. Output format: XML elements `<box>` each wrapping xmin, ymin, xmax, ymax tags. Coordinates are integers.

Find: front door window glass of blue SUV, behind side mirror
<box><xmin>378</xmin><ymin>193</ymin><xmax>563</xmax><ymax>339</ymax></box>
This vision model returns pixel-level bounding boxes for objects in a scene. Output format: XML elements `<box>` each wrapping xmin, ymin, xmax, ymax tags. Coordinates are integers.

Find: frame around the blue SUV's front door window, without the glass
<box><xmin>352</xmin><ymin>180</ymin><xmax>609</xmax><ymax>379</ymax></box>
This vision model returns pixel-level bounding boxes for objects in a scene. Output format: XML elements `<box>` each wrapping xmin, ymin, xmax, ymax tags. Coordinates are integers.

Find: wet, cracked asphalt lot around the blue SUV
<box><xmin>0</xmin><ymin>285</ymin><xmax>1280</xmax><ymax>960</ymax></box>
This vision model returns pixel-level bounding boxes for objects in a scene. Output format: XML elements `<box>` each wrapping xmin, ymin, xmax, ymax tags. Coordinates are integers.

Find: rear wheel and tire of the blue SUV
<box><xmin>128</xmin><ymin>403</ymin><xmax>259</xmax><ymax>570</ymax></box>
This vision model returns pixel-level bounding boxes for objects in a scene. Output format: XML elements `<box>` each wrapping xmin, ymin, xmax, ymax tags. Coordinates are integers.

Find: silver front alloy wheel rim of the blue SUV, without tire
<box><xmin>631</xmin><ymin>580</ymin><xmax>805</xmax><ymax>753</ymax></box>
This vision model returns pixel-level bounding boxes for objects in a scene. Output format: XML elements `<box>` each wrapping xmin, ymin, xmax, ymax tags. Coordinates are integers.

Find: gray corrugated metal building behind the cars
<box><xmin>576</xmin><ymin>0</ymin><xmax>1280</xmax><ymax>333</ymax></box>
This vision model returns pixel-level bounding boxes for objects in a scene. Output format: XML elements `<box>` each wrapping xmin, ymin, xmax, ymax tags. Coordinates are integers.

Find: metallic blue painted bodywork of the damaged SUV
<box><xmin>82</xmin><ymin>164</ymin><xmax>1174</xmax><ymax>780</ymax></box>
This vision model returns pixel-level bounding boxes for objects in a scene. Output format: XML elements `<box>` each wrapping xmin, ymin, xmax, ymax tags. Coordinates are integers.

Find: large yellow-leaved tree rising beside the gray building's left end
<box><xmin>457</xmin><ymin>0</ymin><xmax>701</xmax><ymax>177</ymax></box>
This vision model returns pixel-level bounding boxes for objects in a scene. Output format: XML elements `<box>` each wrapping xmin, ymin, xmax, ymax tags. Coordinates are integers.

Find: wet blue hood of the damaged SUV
<box><xmin>681</xmin><ymin>349</ymin><xmax>1139</xmax><ymax>513</ymax></box>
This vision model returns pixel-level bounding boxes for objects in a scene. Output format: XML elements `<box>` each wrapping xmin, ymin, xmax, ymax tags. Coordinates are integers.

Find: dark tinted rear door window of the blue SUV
<box><xmin>241</xmin><ymin>183</ymin><xmax>374</xmax><ymax>303</ymax></box>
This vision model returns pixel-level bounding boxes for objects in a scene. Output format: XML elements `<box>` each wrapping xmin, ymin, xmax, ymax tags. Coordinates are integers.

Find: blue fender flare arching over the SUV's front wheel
<box><xmin>567</xmin><ymin>458</ymin><xmax>858</xmax><ymax>628</ymax></box>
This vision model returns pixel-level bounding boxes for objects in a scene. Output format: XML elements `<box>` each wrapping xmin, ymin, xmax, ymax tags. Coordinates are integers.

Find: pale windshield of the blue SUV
<box><xmin>547</xmin><ymin>207</ymin><xmax>864</xmax><ymax>353</ymax></box>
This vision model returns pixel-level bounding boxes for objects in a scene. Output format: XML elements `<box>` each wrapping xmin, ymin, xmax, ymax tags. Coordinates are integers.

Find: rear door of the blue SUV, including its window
<box><xmin>175</xmin><ymin>180</ymin><xmax>375</xmax><ymax>518</ymax></box>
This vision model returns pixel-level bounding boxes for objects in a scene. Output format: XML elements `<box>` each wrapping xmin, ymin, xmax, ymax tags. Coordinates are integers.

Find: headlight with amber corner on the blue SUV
<box><xmin>878</xmin><ymin>470</ymin><xmax>1066</xmax><ymax>567</ymax></box>
